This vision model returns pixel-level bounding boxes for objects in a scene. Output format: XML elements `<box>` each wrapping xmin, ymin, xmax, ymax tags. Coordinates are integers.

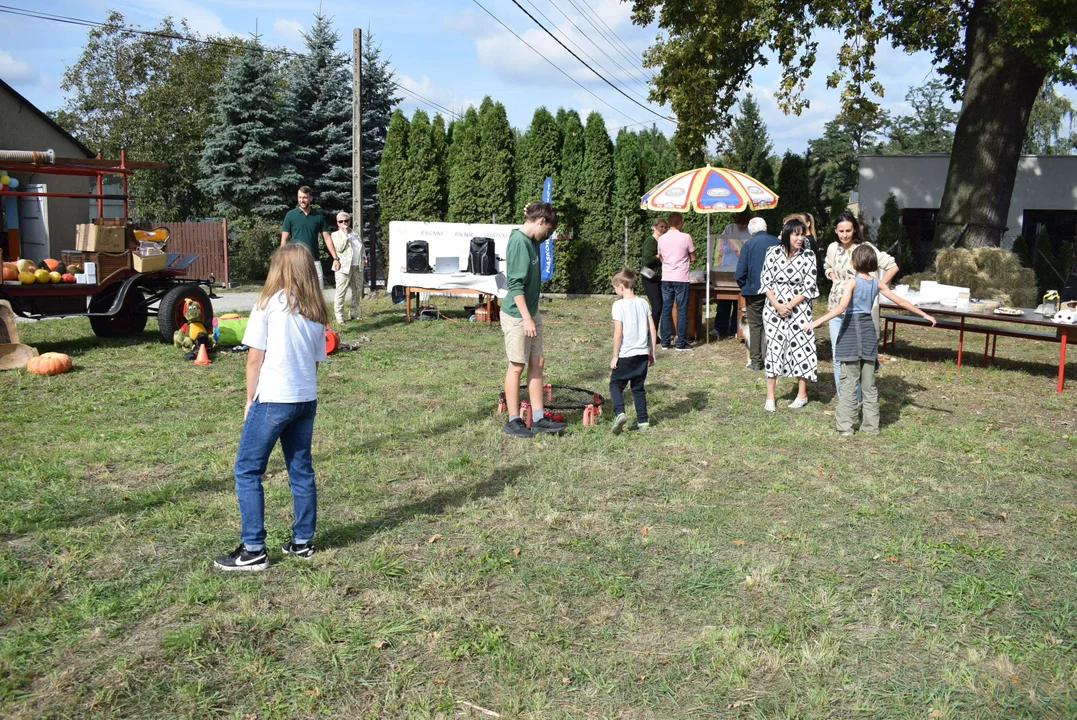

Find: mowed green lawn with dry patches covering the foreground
<box><xmin>0</xmin><ymin>299</ymin><xmax>1077</xmax><ymax>719</ymax></box>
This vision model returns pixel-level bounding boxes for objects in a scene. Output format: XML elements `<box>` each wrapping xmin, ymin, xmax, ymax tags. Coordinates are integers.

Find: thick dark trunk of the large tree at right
<box><xmin>935</xmin><ymin>0</ymin><xmax>1047</xmax><ymax>248</ymax></box>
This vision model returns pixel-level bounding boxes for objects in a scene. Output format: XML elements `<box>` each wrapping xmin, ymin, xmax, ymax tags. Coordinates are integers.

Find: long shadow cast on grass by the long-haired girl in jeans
<box><xmin>319</xmin><ymin>465</ymin><xmax>527</xmax><ymax>548</ymax></box>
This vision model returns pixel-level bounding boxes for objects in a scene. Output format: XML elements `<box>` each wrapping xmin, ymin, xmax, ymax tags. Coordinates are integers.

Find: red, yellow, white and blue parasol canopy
<box><xmin>640</xmin><ymin>166</ymin><xmax>778</xmax><ymax>213</ymax></box>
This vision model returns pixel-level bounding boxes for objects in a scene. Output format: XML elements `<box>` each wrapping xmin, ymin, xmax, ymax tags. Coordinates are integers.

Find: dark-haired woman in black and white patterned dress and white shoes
<box><xmin>759</xmin><ymin>218</ymin><xmax>819</xmax><ymax>412</ymax></box>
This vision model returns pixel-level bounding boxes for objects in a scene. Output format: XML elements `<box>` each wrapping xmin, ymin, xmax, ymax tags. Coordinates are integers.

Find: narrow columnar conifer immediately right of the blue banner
<box><xmin>553</xmin><ymin>108</ymin><xmax>590</xmax><ymax>293</ymax></box>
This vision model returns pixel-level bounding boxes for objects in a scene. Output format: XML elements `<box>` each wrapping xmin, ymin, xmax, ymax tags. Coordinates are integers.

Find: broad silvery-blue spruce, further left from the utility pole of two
<box><xmin>199</xmin><ymin>40</ymin><xmax>299</xmax><ymax>221</ymax></box>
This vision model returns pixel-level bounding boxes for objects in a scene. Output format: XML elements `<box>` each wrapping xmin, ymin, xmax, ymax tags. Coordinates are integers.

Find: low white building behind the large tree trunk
<box><xmin>858</xmin><ymin>153</ymin><xmax>1077</xmax><ymax>261</ymax></box>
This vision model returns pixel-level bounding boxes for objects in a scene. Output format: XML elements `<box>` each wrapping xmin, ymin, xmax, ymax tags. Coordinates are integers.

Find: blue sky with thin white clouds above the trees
<box><xmin>0</xmin><ymin>0</ymin><xmax>1059</xmax><ymax>154</ymax></box>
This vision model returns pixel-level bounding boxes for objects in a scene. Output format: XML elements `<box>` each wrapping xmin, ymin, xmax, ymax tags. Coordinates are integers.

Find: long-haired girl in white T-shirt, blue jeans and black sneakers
<box><xmin>215</xmin><ymin>243</ymin><xmax>330</xmax><ymax>570</ymax></box>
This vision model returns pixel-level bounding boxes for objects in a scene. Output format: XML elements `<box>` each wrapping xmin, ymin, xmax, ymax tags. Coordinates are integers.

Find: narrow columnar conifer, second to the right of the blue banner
<box><xmin>577</xmin><ymin>112</ymin><xmax>624</xmax><ymax>292</ymax></box>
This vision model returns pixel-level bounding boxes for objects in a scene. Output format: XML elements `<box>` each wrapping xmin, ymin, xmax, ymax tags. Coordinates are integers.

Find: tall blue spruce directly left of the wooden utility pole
<box><xmin>285</xmin><ymin>11</ymin><xmax>352</xmax><ymax>212</ymax></box>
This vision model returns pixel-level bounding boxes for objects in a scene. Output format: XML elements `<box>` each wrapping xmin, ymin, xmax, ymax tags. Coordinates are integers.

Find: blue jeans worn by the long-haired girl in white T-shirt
<box><xmin>234</xmin><ymin>400</ymin><xmax>318</xmax><ymax>551</ymax></box>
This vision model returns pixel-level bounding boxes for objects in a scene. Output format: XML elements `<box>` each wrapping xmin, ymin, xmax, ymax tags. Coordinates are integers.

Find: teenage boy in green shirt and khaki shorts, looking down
<box><xmin>501</xmin><ymin>202</ymin><xmax>564</xmax><ymax>438</ymax></box>
